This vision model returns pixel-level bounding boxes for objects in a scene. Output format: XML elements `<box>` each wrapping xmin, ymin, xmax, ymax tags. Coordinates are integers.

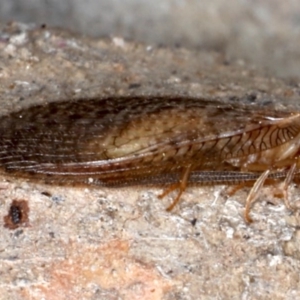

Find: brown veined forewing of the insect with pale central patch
<box><xmin>0</xmin><ymin>97</ymin><xmax>300</xmax><ymax>180</ymax></box>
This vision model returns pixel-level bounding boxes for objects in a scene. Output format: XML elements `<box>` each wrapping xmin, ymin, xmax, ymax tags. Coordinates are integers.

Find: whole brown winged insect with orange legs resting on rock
<box><xmin>0</xmin><ymin>96</ymin><xmax>300</xmax><ymax>222</ymax></box>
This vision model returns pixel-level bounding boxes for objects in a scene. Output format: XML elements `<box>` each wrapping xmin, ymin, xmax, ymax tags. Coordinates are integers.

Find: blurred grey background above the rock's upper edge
<box><xmin>0</xmin><ymin>0</ymin><xmax>300</xmax><ymax>79</ymax></box>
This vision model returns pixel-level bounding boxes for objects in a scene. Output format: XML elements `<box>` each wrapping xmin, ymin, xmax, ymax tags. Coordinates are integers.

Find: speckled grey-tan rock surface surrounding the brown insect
<box><xmin>0</xmin><ymin>23</ymin><xmax>300</xmax><ymax>300</ymax></box>
